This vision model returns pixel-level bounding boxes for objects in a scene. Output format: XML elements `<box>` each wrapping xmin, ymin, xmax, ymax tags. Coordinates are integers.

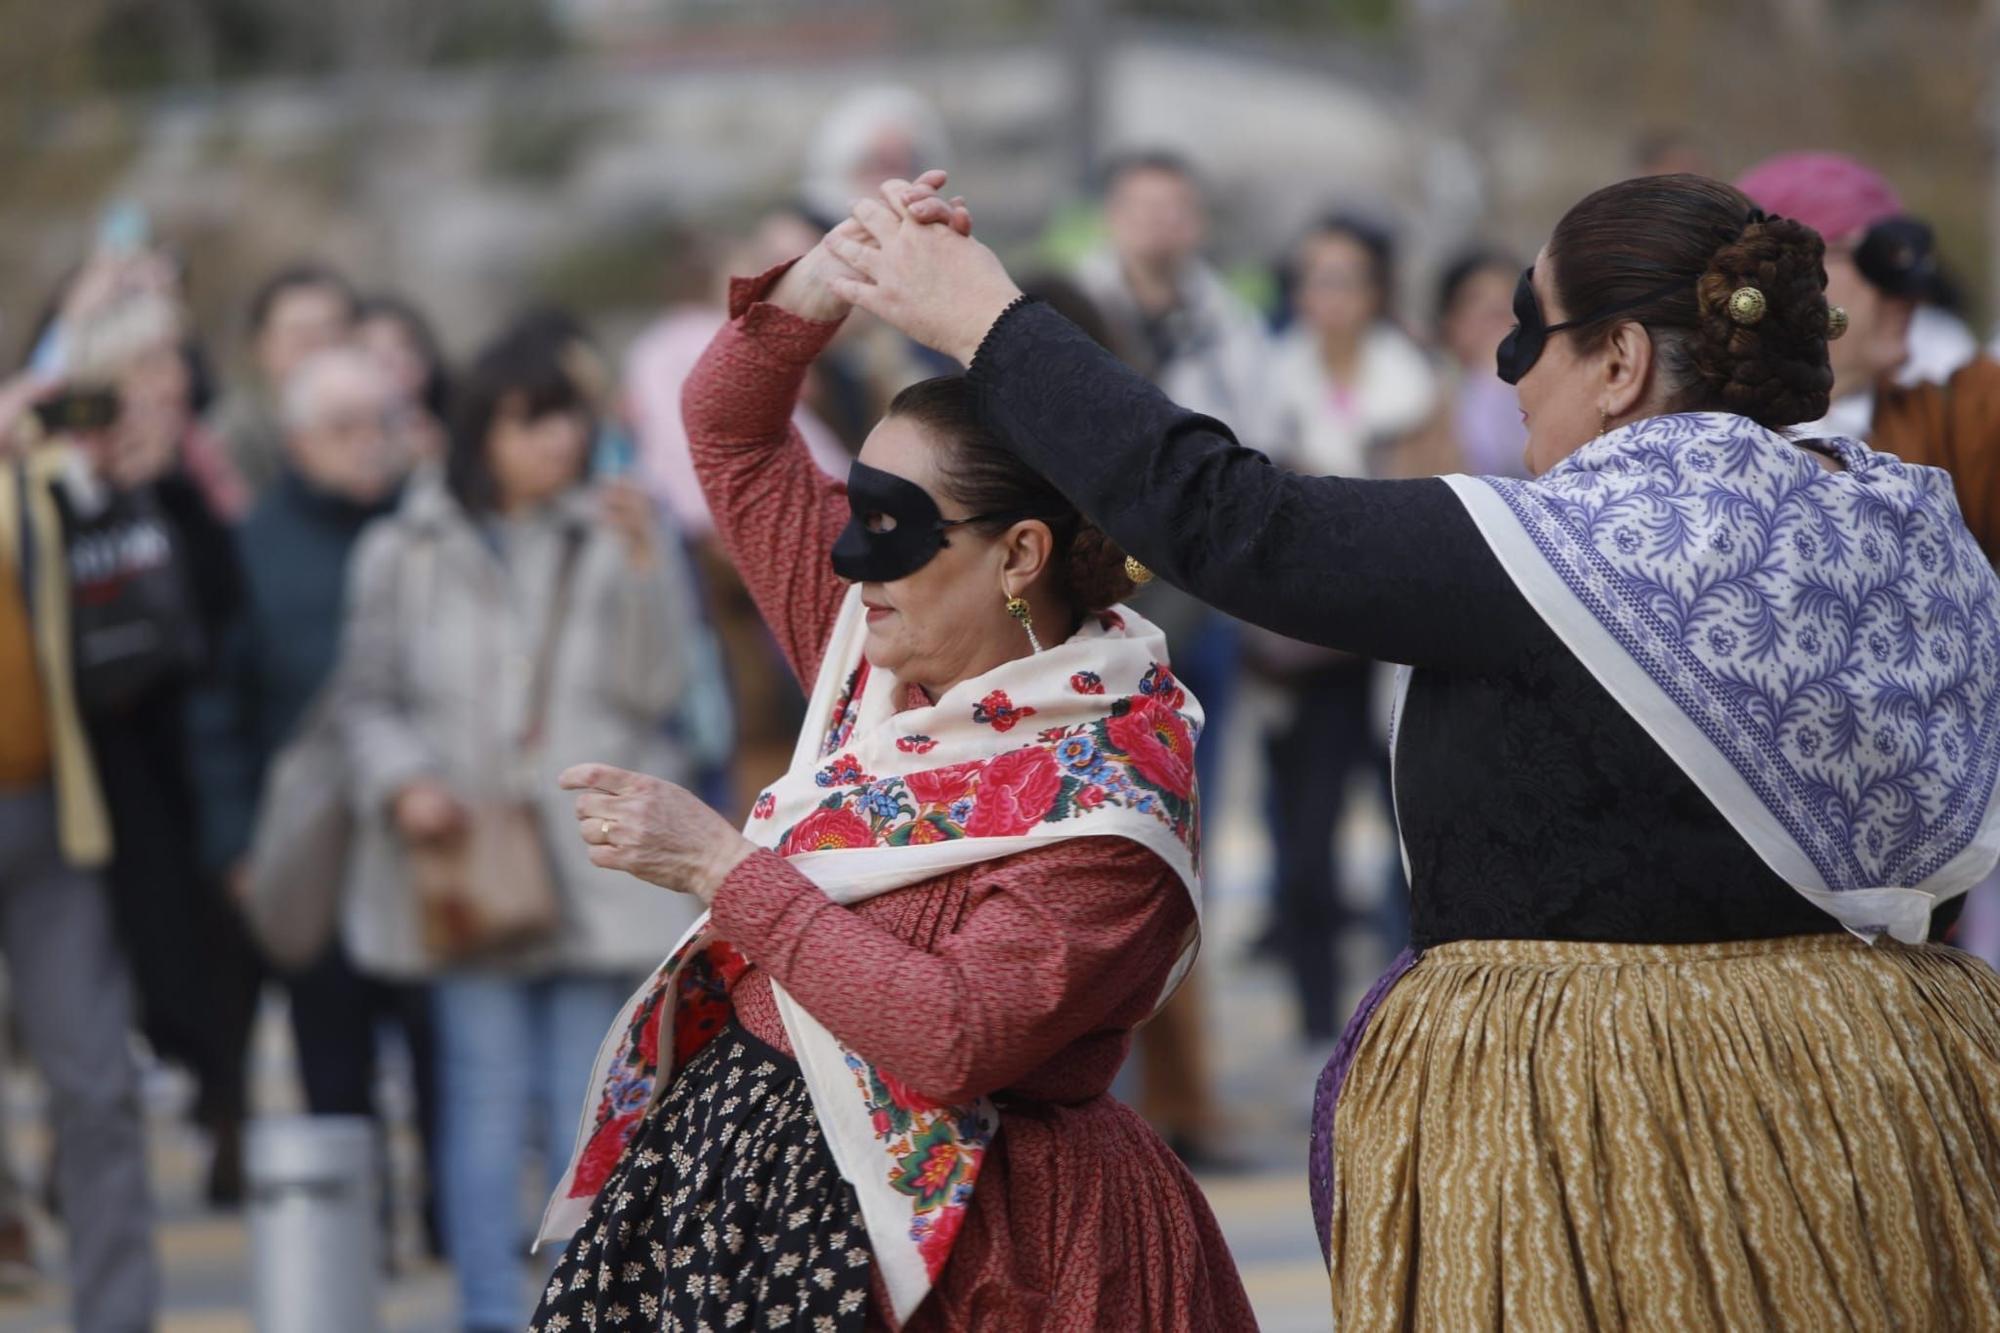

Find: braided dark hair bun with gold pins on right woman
<box><xmin>1688</xmin><ymin>214</ymin><xmax>1834</xmax><ymax>430</ymax></box>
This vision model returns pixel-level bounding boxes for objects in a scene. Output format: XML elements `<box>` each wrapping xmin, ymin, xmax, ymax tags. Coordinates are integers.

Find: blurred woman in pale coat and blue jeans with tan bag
<box><xmin>338</xmin><ymin>314</ymin><xmax>698</xmax><ymax>1331</ymax></box>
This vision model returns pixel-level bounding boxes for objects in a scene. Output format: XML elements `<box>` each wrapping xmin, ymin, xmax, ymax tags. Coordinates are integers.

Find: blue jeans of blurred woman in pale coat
<box><xmin>432</xmin><ymin>975</ymin><xmax>632</xmax><ymax>1329</ymax></box>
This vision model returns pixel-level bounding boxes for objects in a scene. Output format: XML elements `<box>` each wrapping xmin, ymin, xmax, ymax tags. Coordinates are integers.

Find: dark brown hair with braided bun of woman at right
<box><xmin>1548</xmin><ymin>176</ymin><xmax>1834</xmax><ymax>430</ymax></box>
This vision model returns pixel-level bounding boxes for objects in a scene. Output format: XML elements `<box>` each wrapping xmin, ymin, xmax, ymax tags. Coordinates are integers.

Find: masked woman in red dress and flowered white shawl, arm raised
<box><xmin>536</xmin><ymin>176</ymin><xmax>1254</xmax><ymax>1333</ymax></box>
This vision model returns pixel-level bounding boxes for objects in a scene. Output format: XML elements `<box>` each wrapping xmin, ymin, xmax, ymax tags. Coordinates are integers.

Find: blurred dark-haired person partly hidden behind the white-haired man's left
<box><xmin>208</xmin><ymin>262</ymin><xmax>356</xmax><ymax>492</ymax></box>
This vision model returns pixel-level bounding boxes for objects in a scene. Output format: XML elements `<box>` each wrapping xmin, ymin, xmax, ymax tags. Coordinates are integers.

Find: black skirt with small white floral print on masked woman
<box><xmin>530</xmin><ymin>1023</ymin><xmax>874</xmax><ymax>1333</ymax></box>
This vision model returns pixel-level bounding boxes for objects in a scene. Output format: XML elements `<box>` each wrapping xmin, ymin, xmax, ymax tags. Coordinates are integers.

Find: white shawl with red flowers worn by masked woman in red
<box><xmin>540</xmin><ymin>588</ymin><xmax>1202</xmax><ymax>1323</ymax></box>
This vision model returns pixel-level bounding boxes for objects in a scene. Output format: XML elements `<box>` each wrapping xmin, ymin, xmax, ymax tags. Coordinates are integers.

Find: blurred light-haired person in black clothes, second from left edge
<box><xmin>53</xmin><ymin>286</ymin><xmax>260</xmax><ymax>1205</ymax></box>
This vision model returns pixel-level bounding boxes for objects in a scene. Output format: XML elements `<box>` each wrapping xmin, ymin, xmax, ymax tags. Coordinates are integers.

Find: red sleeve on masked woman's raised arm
<box><xmin>680</xmin><ymin>264</ymin><xmax>848</xmax><ymax>691</ymax></box>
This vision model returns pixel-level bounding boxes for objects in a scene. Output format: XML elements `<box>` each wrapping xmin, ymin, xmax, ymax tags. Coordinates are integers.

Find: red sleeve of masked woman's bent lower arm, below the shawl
<box><xmin>714</xmin><ymin>839</ymin><xmax>1194</xmax><ymax>1103</ymax></box>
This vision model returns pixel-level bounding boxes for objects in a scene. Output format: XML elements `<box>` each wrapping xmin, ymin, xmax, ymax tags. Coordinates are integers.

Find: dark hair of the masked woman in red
<box><xmin>888</xmin><ymin>374</ymin><xmax>1134</xmax><ymax>612</ymax></box>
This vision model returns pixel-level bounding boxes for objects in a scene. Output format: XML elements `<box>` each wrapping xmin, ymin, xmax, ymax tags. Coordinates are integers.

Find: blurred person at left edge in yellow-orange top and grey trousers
<box><xmin>0</xmin><ymin>360</ymin><xmax>158</xmax><ymax>1333</ymax></box>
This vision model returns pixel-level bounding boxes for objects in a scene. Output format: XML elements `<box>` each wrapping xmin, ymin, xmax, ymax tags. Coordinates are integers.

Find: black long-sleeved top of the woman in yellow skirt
<box><xmin>972</xmin><ymin>304</ymin><xmax>1838</xmax><ymax>947</ymax></box>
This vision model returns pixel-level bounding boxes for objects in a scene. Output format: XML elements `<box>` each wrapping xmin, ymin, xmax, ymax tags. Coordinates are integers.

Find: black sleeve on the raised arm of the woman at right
<box><xmin>970</xmin><ymin>302</ymin><xmax>1548</xmax><ymax>671</ymax></box>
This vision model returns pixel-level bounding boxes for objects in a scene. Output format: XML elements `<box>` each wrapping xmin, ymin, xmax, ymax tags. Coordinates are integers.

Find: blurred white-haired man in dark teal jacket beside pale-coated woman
<box><xmin>192</xmin><ymin>344</ymin><xmax>446</xmax><ymax>1240</ymax></box>
